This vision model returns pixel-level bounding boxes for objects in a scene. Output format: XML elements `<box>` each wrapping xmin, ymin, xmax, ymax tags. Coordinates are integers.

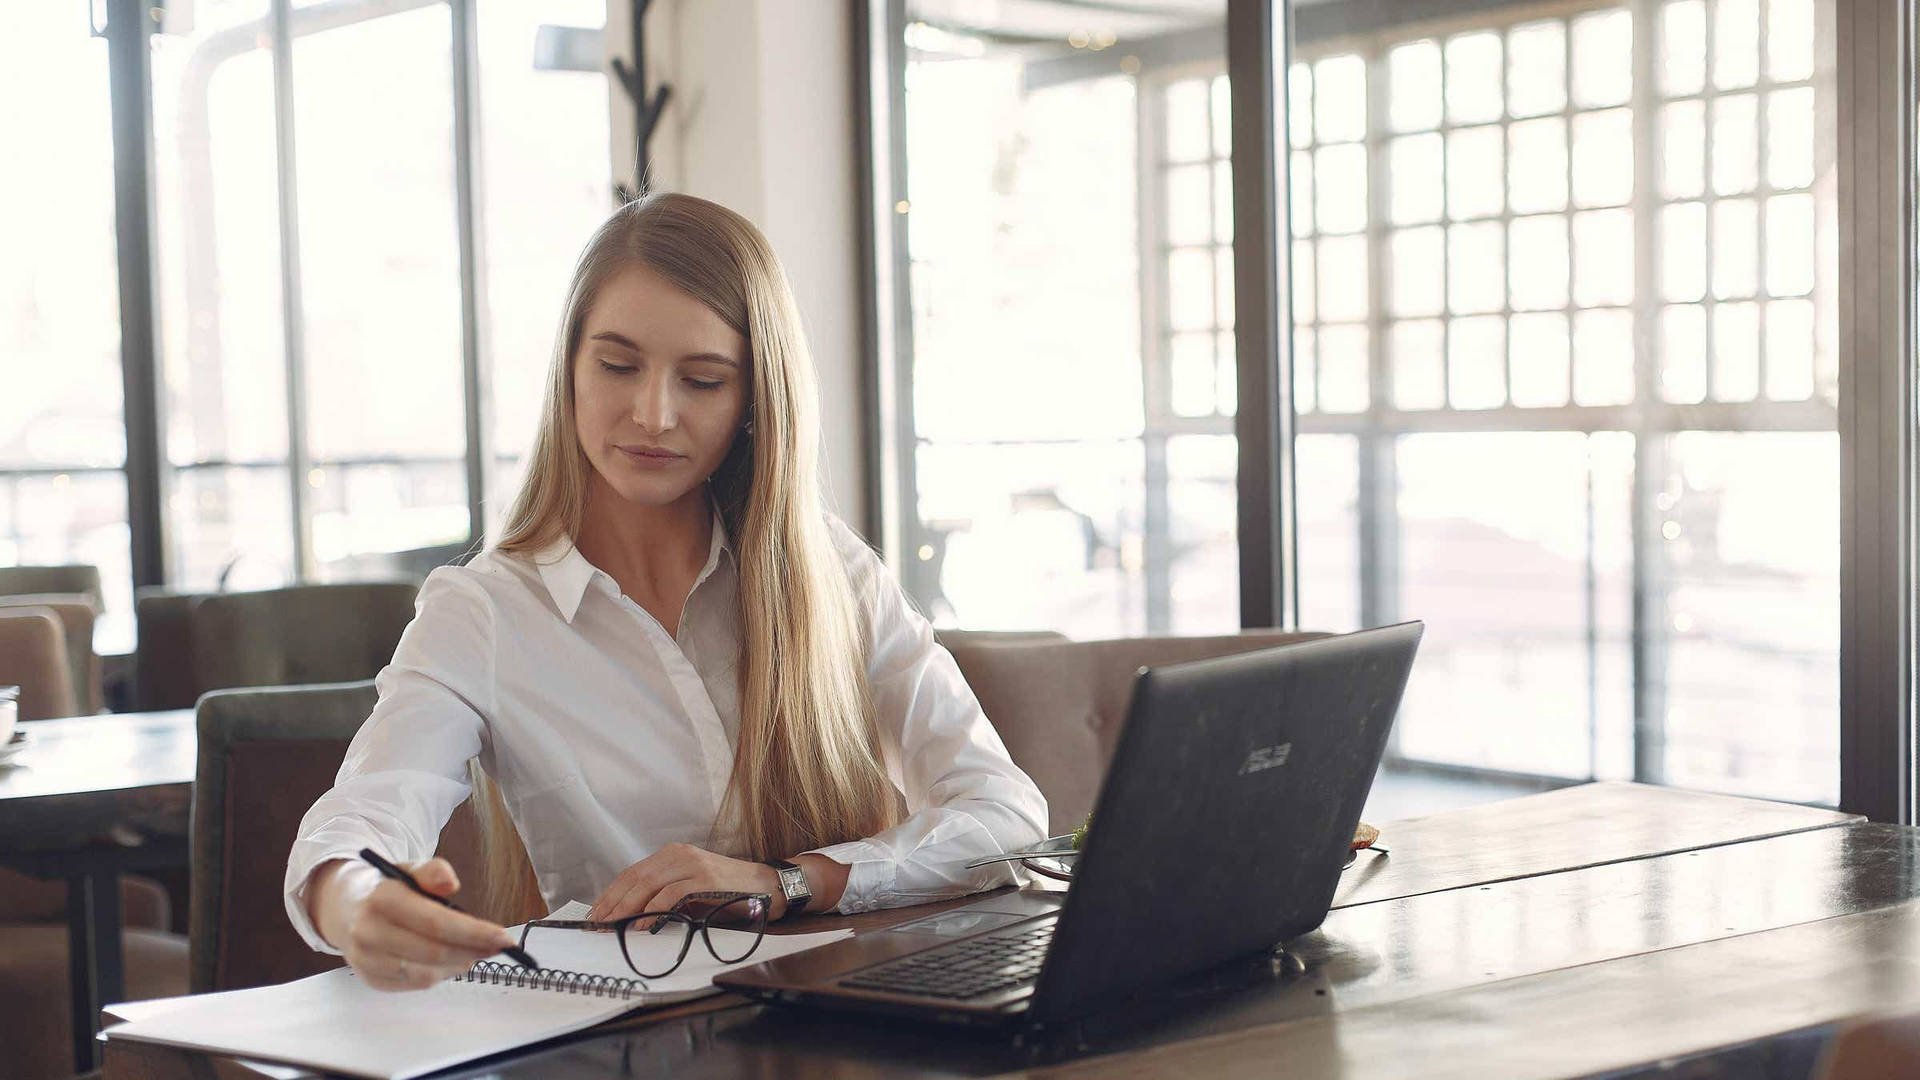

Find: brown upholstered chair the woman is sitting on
<box><xmin>188</xmin><ymin>680</ymin><xmax>503</xmax><ymax>994</ymax></box>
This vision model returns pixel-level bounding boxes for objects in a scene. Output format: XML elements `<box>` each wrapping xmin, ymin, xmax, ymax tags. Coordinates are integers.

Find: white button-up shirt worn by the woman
<box><xmin>286</xmin><ymin>513</ymin><xmax>1046</xmax><ymax>951</ymax></box>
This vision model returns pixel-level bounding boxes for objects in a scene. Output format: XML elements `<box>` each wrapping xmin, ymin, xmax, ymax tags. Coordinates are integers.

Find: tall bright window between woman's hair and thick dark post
<box><xmin>897</xmin><ymin>0</ymin><xmax>1236</xmax><ymax>636</ymax></box>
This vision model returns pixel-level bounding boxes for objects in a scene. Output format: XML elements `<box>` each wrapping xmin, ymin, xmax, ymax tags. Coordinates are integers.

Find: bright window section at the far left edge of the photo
<box><xmin>0</xmin><ymin>4</ymin><xmax>132</xmax><ymax>648</ymax></box>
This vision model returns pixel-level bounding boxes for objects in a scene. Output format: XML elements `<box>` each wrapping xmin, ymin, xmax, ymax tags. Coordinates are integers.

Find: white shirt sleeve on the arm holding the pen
<box><xmin>286</xmin><ymin>567</ymin><xmax>493</xmax><ymax>953</ymax></box>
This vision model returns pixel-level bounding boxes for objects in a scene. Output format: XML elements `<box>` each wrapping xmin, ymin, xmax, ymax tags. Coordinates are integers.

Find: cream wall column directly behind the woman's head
<box><xmin>607</xmin><ymin>0</ymin><xmax>866</xmax><ymax>530</ymax></box>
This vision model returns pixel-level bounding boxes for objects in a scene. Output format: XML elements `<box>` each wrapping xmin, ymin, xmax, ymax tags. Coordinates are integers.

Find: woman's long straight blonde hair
<box><xmin>472</xmin><ymin>194</ymin><xmax>899</xmax><ymax>911</ymax></box>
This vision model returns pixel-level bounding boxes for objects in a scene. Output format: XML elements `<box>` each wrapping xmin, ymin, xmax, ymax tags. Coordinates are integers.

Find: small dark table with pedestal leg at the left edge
<box><xmin>0</xmin><ymin>709</ymin><xmax>198</xmax><ymax>1072</ymax></box>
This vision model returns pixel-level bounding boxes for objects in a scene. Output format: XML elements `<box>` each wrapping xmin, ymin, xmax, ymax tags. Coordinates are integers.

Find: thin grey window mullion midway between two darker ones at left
<box><xmin>269</xmin><ymin>0</ymin><xmax>313</xmax><ymax>580</ymax></box>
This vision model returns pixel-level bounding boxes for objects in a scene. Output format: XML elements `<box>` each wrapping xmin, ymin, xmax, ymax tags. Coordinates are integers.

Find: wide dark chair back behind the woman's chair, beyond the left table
<box><xmin>134</xmin><ymin>582</ymin><xmax>419</xmax><ymax>719</ymax></box>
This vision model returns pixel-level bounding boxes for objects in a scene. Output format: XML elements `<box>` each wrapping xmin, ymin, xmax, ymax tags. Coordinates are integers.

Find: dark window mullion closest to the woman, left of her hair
<box><xmin>449</xmin><ymin>0</ymin><xmax>493</xmax><ymax>544</ymax></box>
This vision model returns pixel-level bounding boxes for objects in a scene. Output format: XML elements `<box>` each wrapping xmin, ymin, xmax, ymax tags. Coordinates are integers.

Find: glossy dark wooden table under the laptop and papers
<box><xmin>106</xmin><ymin>784</ymin><xmax>1920</xmax><ymax>1080</ymax></box>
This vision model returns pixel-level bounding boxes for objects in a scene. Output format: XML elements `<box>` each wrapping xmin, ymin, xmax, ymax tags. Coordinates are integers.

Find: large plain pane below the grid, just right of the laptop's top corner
<box><xmin>1396</xmin><ymin>432</ymin><xmax>1632</xmax><ymax>776</ymax></box>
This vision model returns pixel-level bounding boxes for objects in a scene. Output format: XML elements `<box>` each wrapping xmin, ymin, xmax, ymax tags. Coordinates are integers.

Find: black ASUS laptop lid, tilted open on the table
<box><xmin>1029</xmin><ymin>623</ymin><xmax>1423</xmax><ymax>1019</ymax></box>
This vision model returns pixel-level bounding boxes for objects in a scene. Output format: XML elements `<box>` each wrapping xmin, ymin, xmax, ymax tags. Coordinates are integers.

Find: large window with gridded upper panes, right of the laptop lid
<box><xmin>1286</xmin><ymin>0</ymin><xmax>1839</xmax><ymax>801</ymax></box>
